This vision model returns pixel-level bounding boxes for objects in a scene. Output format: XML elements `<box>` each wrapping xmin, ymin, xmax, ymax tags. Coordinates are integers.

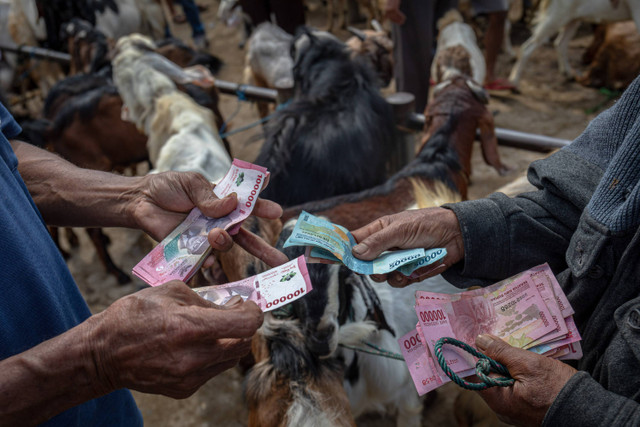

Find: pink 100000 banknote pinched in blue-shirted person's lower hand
<box><xmin>193</xmin><ymin>256</ymin><xmax>313</xmax><ymax>311</ymax></box>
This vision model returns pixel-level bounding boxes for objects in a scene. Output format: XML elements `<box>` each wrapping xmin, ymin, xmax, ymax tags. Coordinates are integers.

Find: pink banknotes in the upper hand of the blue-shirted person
<box><xmin>133</xmin><ymin>159</ymin><xmax>269</xmax><ymax>286</ymax></box>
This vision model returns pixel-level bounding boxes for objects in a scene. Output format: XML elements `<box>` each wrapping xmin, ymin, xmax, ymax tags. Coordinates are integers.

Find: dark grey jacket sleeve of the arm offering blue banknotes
<box><xmin>444</xmin><ymin>149</ymin><xmax>603</xmax><ymax>287</ymax></box>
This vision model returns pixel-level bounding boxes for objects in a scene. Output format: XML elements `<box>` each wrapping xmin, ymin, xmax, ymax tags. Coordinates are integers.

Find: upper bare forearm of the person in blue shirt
<box><xmin>12</xmin><ymin>141</ymin><xmax>143</xmax><ymax>227</ymax></box>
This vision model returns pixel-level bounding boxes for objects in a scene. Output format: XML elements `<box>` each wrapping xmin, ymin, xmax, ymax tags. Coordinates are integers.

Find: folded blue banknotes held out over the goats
<box><xmin>284</xmin><ymin>211</ymin><xmax>447</xmax><ymax>277</ymax></box>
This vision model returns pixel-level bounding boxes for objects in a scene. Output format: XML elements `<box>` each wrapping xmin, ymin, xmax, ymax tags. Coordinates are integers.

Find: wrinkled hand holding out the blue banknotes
<box><xmin>352</xmin><ymin>208</ymin><xmax>464</xmax><ymax>287</ymax></box>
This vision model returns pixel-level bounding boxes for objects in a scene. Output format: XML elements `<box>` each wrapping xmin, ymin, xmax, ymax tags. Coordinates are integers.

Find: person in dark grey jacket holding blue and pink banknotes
<box><xmin>353</xmin><ymin>73</ymin><xmax>640</xmax><ymax>426</ymax></box>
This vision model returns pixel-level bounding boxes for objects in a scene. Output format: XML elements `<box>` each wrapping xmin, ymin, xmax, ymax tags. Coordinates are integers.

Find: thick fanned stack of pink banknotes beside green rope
<box><xmin>398</xmin><ymin>264</ymin><xmax>582</xmax><ymax>395</ymax></box>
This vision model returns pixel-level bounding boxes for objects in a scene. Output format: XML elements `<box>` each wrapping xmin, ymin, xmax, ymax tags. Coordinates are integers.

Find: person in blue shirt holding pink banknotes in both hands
<box><xmin>0</xmin><ymin>104</ymin><xmax>287</xmax><ymax>427</ymax></box>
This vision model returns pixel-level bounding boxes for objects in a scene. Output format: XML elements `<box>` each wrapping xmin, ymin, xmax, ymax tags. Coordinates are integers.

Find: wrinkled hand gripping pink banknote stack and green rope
<box><xmin>476</xmin><ymin>335</ymin><xmax>578</xmax><ymax>426</ymax></box>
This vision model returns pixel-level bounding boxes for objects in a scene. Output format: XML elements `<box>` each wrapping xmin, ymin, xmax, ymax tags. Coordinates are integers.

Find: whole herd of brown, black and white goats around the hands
<box><xmin>3</xmin><ymin>0</ymin><xmax>640</xmax><ymax>427</ymax></box>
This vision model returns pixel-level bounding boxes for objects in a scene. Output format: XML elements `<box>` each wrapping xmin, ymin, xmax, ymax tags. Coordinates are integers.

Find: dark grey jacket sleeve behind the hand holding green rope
<box><xmin>542</xmin><ymin>372</ymin><xmax>640</xmax><ymax>427</ymax></box>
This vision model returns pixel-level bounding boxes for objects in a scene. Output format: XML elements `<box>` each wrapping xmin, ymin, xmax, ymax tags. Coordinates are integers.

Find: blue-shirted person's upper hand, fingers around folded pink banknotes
<box><xmin>132</xmin><ymin>172</ymin><xmax>288</xmax><ymax>268</ymax></box>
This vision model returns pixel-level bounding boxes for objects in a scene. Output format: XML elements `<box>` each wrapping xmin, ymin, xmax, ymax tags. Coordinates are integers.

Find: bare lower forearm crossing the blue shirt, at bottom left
<box><xmin>0</xmin><ymin>319</ymin><xmax>110</xmax><ymax>425</ymax></box>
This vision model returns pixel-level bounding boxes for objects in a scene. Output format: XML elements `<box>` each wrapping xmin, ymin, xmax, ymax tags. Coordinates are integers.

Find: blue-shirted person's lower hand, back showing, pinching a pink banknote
<box><xmin>88</xmin><ymin>281</ymin><xmax>263</xmax><ymax>398</ymax></box>
